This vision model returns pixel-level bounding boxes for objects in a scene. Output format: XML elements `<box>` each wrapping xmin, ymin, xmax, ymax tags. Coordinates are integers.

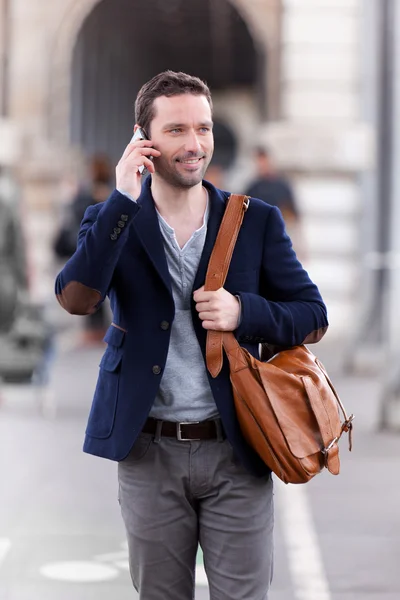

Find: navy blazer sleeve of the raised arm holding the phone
<box><xmin>55</xmin><ymin>190</ymin><xmax>140</xmax><ymax>315</ymax></box>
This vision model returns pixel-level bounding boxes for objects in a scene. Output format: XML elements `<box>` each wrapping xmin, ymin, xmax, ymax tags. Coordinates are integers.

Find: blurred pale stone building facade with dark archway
<box><xmin>0</xmin><ymin>0</ymin><xmax>378</xmax><ymax>339</ymax></box>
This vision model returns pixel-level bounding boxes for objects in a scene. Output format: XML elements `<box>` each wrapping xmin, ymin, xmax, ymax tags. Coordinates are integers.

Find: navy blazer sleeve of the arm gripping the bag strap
<box><xmin>236</xmin><ymin>207</ymin><xmax>328</xmax><ymax>346</ymax></box>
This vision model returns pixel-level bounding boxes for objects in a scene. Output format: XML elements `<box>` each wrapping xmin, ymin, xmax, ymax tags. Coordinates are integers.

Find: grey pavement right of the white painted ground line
<box><xmin>286</xmin><ymin>345</ymin><xmax>400</xmax><ymax>600</ymax></box>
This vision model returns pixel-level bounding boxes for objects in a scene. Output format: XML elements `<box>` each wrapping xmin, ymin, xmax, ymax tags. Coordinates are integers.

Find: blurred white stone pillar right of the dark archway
<box><xmin>261</xmin><ymin>0</ymin><xmax>373</xmax><ymax>340</ymax></box>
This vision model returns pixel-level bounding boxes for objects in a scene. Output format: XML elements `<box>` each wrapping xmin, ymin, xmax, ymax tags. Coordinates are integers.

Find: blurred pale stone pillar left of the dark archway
<box><xmin>9</xmin><ymin>0</ymin><xmax>76</xmax><ymax>301</ymax></box>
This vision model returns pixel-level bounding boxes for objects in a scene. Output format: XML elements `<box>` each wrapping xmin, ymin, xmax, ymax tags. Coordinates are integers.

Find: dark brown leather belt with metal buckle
<box><xmin>142</xmin><ymin>417</ymin><xmax>226</xmax><ymax>442</ymax></box>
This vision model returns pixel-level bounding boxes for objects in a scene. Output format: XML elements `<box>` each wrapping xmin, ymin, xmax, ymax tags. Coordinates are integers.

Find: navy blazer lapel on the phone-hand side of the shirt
<box><xmin>133</xmin><ymin>176</ymin><xmax>172</xmax><ymax>296</ymax></box>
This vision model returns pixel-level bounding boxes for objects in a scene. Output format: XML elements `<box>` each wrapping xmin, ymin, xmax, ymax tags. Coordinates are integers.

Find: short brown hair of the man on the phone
<box><xmin>135</xmin><ymin>71</ymin><xmax>213</xmax><ymax>135</ymax></box>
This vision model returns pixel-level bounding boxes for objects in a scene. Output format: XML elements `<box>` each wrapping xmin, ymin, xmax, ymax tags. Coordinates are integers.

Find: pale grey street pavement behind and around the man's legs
<box><xmin>0</xmin><ymin>338</ymin><xmax>400</xmax><ymax>600</ymax></box>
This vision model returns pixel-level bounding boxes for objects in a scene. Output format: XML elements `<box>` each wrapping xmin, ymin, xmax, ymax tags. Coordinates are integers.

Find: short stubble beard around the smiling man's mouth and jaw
<box><xmin>154</xmin><ymin>152</ymin><xmax>212</xmax><ymax>189</ymax></box>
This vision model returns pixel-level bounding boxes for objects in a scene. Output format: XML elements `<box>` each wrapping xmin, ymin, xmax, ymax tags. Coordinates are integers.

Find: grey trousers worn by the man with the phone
<box><xmin>118</xmin><ymin>433</ymin><xmax>274</xmax><ymax>600</ymax></box>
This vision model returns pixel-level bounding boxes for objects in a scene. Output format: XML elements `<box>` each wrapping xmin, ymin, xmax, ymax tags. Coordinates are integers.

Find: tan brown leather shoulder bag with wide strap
<box><xmin>205</xmin><ymin>194</ymin><xmax>354</xmax><ymax>483</ymax></box>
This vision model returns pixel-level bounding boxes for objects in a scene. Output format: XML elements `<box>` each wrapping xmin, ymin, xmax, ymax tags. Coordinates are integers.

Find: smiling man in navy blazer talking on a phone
<box><xmin>56</xmin><ymin>71</ymin><xmax>327</xmax><ymax>600</ymax></box>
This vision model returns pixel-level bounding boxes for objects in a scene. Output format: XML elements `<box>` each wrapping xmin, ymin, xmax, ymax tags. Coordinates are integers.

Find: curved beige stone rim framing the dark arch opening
<box><xmin>47</xmin><ymin>0</ymin><xmax>282</xmax><ymax>148</ymax></box>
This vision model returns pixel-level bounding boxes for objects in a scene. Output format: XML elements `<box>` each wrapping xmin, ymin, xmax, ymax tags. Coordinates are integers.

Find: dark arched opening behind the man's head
<box><xmin>70</xmin><ymin>0</ymin><xmax>261</xmax><ymax>162</ymax></box>
